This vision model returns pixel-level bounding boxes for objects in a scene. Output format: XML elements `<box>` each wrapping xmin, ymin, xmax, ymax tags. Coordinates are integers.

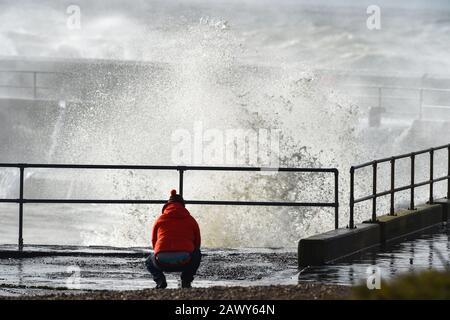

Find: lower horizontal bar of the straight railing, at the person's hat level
<box><xmin>0</xmin><ymin>199</ymin><xmax>338</xmax><ymax>207</ymax></box>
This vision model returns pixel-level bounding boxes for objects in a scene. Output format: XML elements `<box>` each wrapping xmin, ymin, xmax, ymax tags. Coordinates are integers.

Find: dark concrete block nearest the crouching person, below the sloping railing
<box><xmin>298</xmin><ymin>223</ymin><xmax>380</xmax><ymax>267</ymax></box>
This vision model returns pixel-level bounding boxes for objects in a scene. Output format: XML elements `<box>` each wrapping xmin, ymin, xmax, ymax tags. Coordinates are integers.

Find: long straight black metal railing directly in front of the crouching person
<box><xmin>0</xmin><ymin>164</ymin><xmax>339</xmax><ymax>251</ymax></box>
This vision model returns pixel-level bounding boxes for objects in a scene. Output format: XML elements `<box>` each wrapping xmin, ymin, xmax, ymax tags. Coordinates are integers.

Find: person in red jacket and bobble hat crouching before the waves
<box><xmin>145</xmin><ymin>190</ymin><xmax>201</xmax><ymax>289</ymax></box>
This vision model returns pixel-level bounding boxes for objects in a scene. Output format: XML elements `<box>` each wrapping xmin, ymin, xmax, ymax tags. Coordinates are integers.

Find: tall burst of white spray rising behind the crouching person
<box><xmin>0</xmin><ymin>17</ymin><xmax>364</xmax><ymax>247</ymax></box>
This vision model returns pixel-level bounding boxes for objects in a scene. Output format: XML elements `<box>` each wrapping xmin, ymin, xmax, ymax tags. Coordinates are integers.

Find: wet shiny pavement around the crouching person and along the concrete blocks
<box><xmin>0</xmin><ymin>226</ymin><xmax>450</xmax><ymax>296</ymax></box>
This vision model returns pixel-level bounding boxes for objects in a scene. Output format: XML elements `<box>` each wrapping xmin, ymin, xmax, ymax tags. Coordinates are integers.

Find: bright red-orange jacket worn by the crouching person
<box><xmin>152</xmin><ymin>202</ymin><xmax>201</xmax><ymax>255</ymax></box>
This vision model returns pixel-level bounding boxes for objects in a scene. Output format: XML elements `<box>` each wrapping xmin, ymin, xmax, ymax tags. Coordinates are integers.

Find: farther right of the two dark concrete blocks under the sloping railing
<box><xmin>378</xmin><ymin>204</ymin><xmax>443</xmax><ymax>243</ymax></box>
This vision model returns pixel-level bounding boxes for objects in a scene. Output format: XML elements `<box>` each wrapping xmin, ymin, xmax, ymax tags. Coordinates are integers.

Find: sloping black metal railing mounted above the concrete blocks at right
<box><xmin>349</xmin><ymin>144</ymin><xmax>450</xmax><ymax>229</ymax></box>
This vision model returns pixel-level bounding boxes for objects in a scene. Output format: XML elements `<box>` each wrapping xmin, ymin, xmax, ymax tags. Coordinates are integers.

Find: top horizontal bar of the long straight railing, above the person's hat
<box><xmin>0</xmin><ymin>163</ymin><xmax>337</xmax><ymax>173</ymax></box>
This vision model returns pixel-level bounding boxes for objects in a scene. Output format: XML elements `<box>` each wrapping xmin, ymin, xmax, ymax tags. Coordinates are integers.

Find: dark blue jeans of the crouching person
<box><xmin>145</xmin><ymin>249</ymin><xmax>202</xmax><ymax>283</ymax></box>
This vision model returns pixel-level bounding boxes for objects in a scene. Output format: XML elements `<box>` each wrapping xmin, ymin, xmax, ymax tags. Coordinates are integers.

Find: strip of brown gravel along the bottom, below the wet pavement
<box><xmin>21</xmin><ymin>283</ymin><xmax>351</xmax><ymax>300</ymax></box>
